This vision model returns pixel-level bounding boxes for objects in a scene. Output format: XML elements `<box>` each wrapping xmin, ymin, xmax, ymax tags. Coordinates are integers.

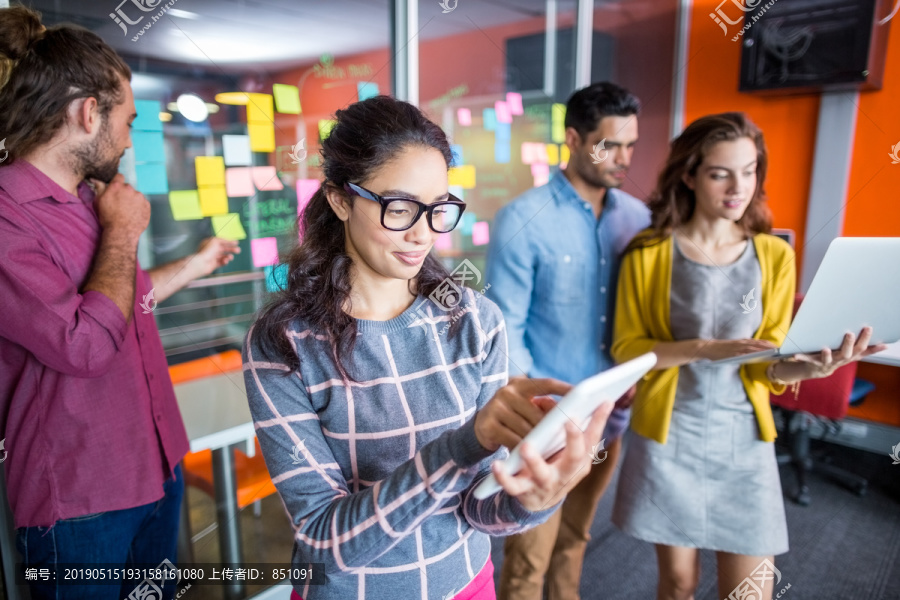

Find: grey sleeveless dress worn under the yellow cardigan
<box><xmin>613</xmin><ymin>240</ymin><xmax>788</xmax><ymax>556</ymax></box>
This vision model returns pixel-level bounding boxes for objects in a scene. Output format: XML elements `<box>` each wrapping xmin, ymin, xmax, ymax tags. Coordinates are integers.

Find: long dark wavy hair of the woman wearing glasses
<box><xmin>254</xmin><ymin>96</ymin><xmax>458</xmax><ymax>379</ymax></box>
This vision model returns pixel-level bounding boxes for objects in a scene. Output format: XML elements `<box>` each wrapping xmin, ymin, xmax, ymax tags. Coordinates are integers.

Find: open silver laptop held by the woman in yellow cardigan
<box><xmin>706</xmin><ymin>237</ymin><xmax>900</xmax><ymax>365</ymax></box>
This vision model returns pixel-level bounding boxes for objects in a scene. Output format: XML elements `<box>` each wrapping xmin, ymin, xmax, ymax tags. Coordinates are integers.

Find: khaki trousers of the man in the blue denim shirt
<box><xmin>497</xmin><ymin>437</ymin><xmax>622</xmax><ymax>600</ymax></box>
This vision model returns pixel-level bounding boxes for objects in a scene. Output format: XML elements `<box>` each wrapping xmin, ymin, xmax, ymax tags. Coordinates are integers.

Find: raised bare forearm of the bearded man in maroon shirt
<box><xmin>82</xmin><ymin>228</ymin><xmax>138</xmax><ymax>320</ymax></box>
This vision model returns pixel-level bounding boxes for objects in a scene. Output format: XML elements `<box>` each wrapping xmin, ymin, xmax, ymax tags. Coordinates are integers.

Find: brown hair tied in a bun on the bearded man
<box><xmin>0</xmin><ymin>6</ymin><xmax>131</xmax><ymax>160</ymax></box>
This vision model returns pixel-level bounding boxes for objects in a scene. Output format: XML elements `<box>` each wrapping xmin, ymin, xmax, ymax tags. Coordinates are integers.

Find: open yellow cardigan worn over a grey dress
<box><xmin>612</xmin><ymin>230</ymin><xmax>796</xmax><ymax>444</ymax></box>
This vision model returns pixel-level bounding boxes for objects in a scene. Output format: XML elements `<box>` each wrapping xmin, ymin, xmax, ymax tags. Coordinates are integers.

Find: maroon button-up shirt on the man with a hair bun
<box><xmin>0</xmin><ymin>160</ymin><xmax>188</xmax><ymax>527</ymax></box>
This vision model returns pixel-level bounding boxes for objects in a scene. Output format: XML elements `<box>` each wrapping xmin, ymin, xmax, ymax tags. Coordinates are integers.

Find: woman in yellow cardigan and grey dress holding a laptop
<box><xmin>612</xmin><ymin>113</ymin><xmax>881</xmax><ymax>600</ymax></box>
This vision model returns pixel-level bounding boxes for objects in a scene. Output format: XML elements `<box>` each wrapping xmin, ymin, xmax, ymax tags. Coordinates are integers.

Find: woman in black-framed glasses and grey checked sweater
<box><xmin>244</xmin><ymin>96</ymin><xmax>606</xmax><ymax>600</ymax></box>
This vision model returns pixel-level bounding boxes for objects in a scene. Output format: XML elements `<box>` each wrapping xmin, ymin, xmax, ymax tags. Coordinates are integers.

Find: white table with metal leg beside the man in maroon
<box><xmin>175</xmin><ymin>371</ymin><xmax>255</xmax><ymax>600</ymax></box>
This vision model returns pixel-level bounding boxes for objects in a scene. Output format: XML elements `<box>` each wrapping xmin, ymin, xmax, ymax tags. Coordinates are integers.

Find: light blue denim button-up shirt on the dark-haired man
<box><xmin>485</xmin><ymin>172</ymin><xmax>650</xmax><ymax>384</ymax></box>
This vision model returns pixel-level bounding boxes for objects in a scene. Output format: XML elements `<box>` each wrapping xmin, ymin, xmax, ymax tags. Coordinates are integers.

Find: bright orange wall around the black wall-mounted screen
<box><xmin>685</xmin><ymin>0</ymin><xmax>900</xmax><ymax>426</ymax></box>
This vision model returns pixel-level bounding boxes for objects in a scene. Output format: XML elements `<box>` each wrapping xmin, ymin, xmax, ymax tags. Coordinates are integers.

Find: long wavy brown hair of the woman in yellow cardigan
<box><xmin>629</xmin><ymin>112</ymin><xmax>772</xmax><ymax>249</ymax></box>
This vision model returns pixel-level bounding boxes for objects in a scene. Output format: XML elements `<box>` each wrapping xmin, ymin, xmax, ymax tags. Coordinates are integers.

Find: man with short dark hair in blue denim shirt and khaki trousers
<box><xmin>485</xmin><ymin>82</ymin><xmax>650</xmax><ymax>600</ymax></box>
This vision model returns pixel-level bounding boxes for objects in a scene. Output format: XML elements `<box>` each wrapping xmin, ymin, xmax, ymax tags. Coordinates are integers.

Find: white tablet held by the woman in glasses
<box><xmin>475</xmin><ymin>352</ymin><xmax>656</xmax><ymax>500</ymax></box>
